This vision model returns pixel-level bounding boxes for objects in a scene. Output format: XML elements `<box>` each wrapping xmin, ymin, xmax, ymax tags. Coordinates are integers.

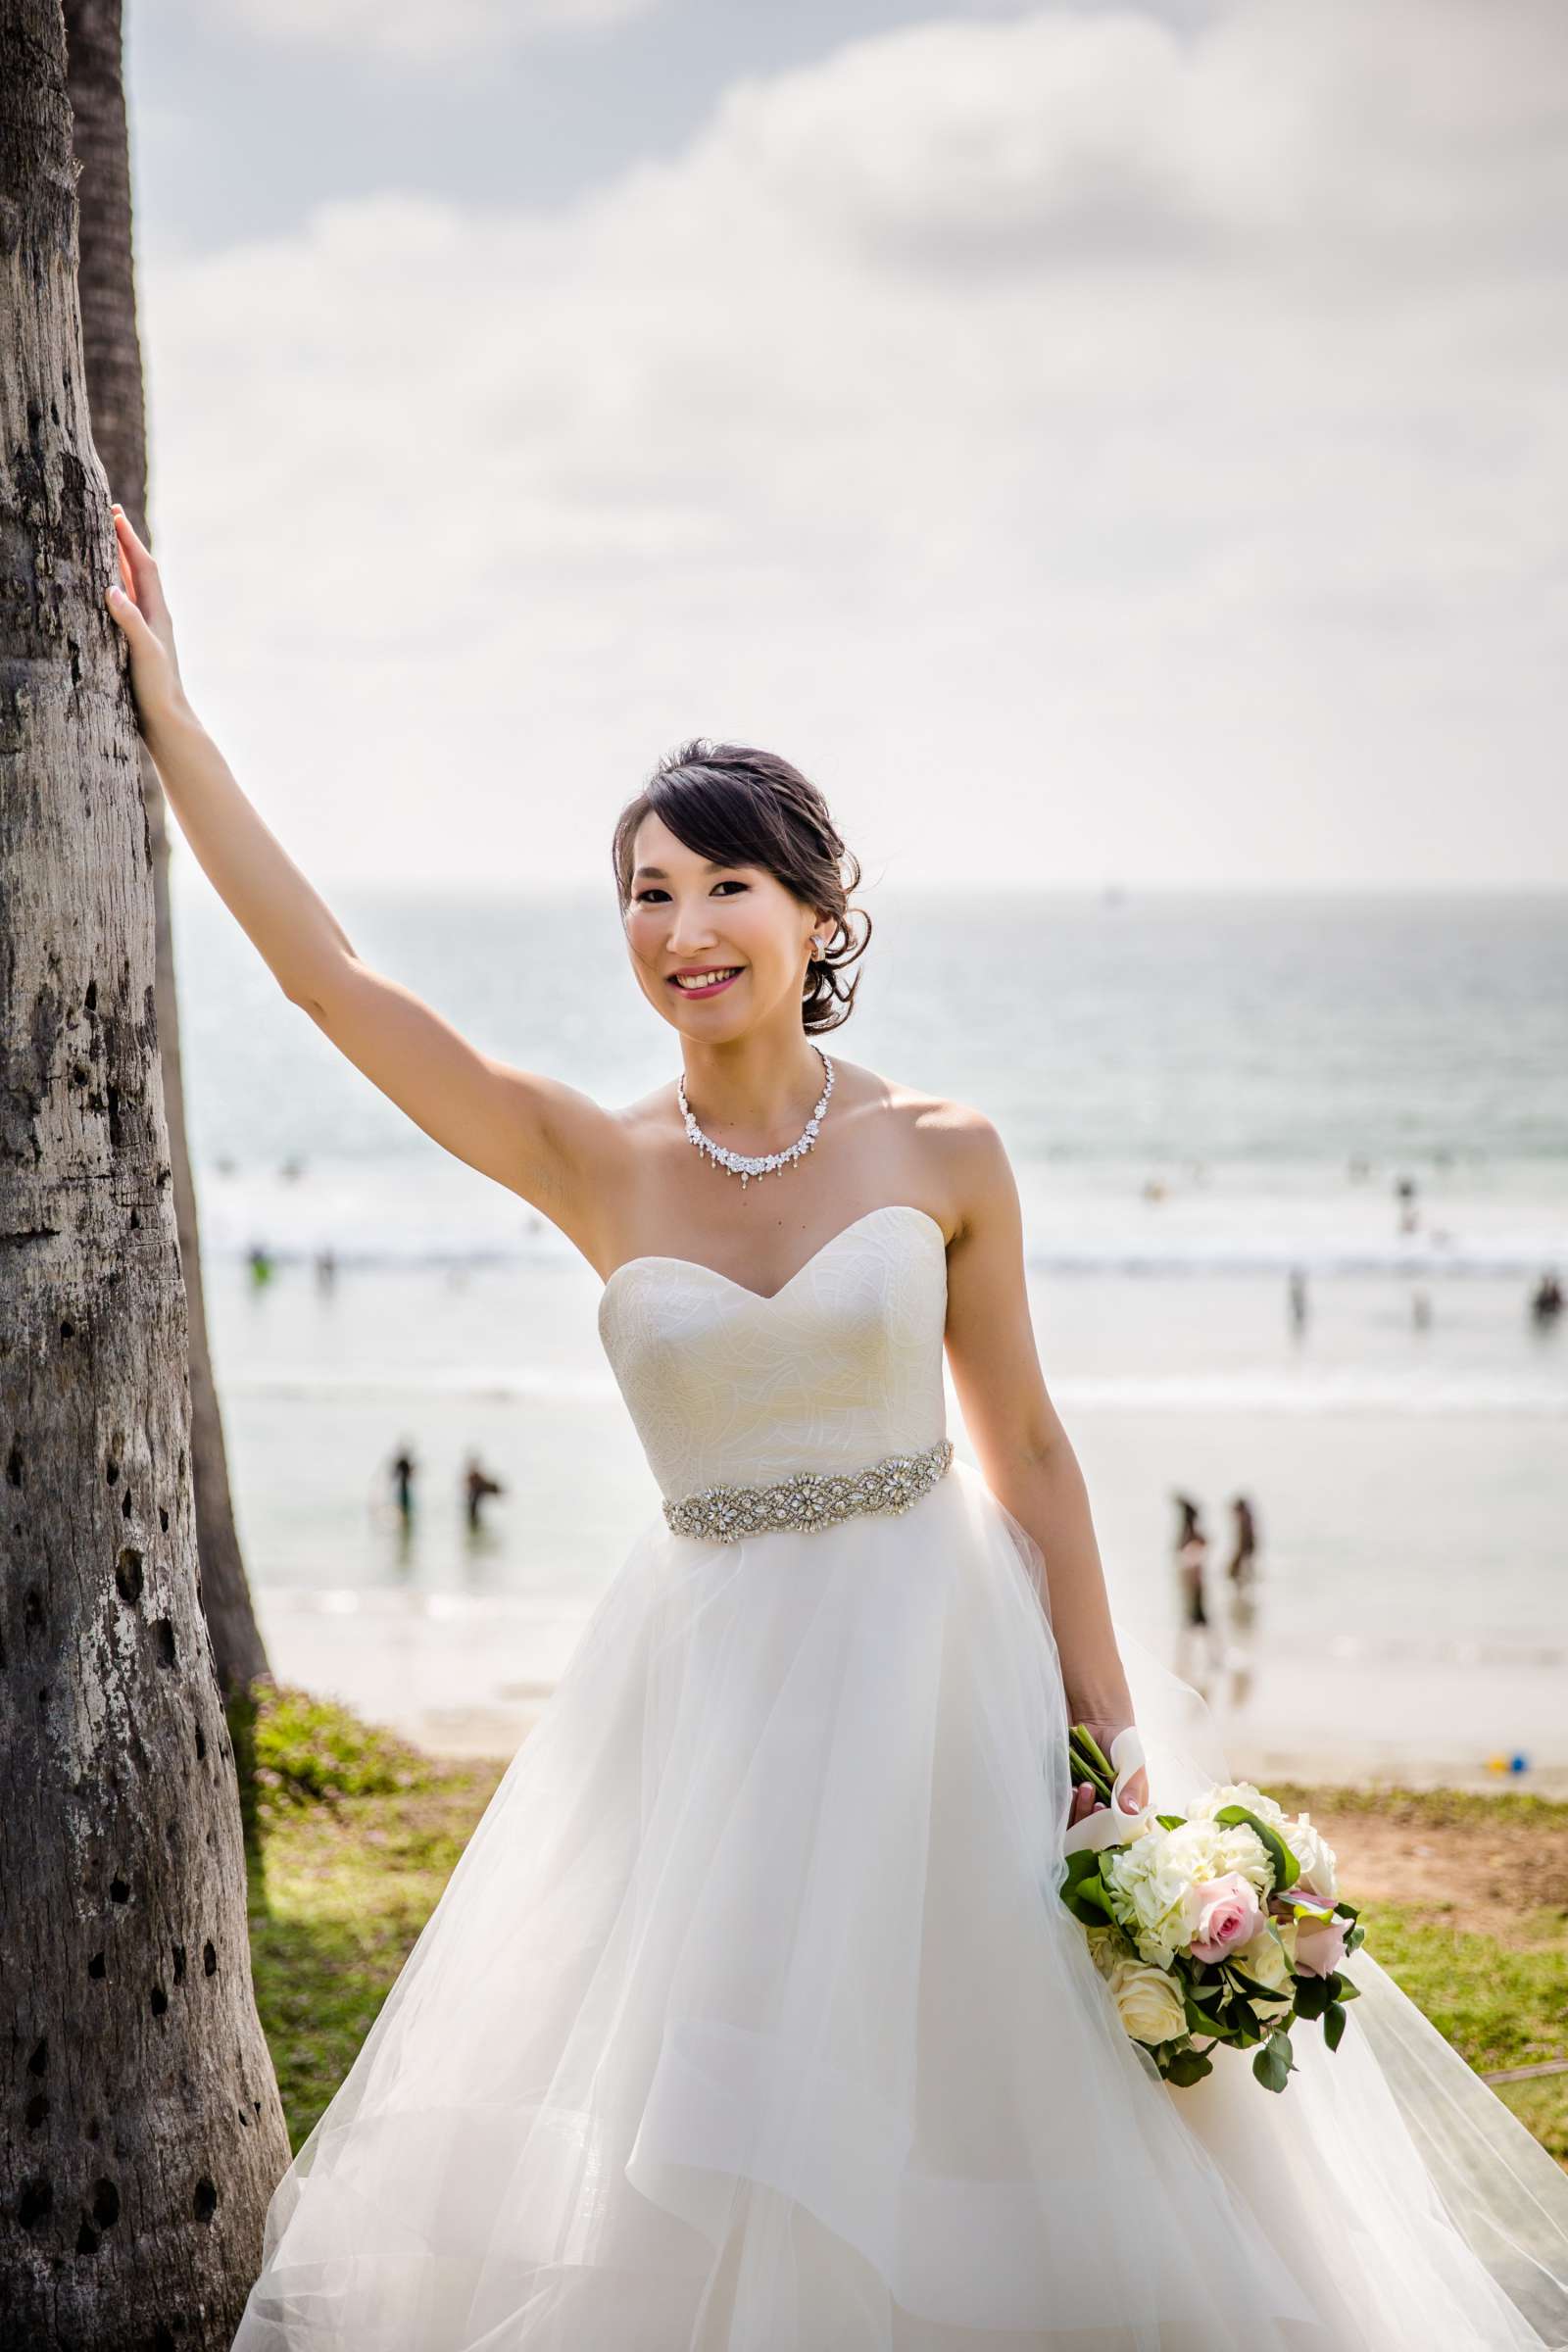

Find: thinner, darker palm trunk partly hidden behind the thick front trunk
<box><xmin>66</xmin><ymin>0</ymin><xmax>270</xmax><ymax>1695</ymax></box>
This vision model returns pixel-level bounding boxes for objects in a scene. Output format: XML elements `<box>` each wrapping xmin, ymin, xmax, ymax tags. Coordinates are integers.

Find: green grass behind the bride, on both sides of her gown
<box><xmin>252</xmin><ymin>1691</ymin><xmax>1568</xmax><ymax>2162</ymax></box>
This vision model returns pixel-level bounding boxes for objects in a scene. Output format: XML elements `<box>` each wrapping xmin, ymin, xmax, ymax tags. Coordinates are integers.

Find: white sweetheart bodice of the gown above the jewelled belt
<box><xmin>600</xmin><ymin>1201</ymin><xmax>948</xmax><ymax>1495</ymax></box>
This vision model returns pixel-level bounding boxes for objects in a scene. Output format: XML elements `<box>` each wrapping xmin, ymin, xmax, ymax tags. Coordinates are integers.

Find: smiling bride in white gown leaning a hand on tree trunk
<box><xmin>111</xmin><ymin>511</ymin><xmax>1568</xmax><ymax>2352</ymax></box>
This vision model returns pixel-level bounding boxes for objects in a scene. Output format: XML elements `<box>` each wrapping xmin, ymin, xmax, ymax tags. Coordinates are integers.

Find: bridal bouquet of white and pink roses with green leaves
<box><xmin>1062</xmin><ymin>1724</ymin><xmax>1363</xmax><ymax>2091</ymax></box>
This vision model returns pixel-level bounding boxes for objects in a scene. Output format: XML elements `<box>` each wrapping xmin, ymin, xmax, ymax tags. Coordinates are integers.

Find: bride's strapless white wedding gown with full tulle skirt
<box><xmin>235</xmin><ymin>1204</ymin><xmax>1568</xmax><ymax>2352</ymax></box>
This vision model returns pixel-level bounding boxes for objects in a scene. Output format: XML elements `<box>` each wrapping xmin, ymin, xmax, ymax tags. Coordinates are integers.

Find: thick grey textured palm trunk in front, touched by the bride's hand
<box><xmin>0</xmin><ymin>0</ymin><xmax>287</xmax><ymax>2352</ymax></box>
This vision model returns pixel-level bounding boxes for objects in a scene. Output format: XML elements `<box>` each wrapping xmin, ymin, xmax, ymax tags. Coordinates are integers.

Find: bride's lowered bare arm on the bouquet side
<box><xmin>948</xmin><ymin>1105</ymin><xmax>1145</xmax><ymax>1821</ymax></box>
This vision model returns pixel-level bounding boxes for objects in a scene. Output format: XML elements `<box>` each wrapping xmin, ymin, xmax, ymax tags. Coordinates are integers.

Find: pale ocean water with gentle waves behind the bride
<box><xmin>176</xmin><ymin>872</ymin><xmax>1568</xmax><ymax>1786</ymax></box>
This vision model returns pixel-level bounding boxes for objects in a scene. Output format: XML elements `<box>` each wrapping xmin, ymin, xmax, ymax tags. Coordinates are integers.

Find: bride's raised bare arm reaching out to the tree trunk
<box><xmin>108</xmin><ymin>508</ymin><xmax>618</xmax><ymax>1247</ymax></box>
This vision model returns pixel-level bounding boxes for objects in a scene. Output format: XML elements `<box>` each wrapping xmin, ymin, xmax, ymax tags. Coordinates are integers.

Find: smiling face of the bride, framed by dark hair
<box><xmin>623</xmin><ymin>813</ymin><xmax>815</xmax><ymax>1042</ymax></box>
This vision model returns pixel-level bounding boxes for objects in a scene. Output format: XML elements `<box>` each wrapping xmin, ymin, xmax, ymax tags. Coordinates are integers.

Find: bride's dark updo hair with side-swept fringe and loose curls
<box><xmin>612</xmin><ymin>736</ymin><xmax>872</xmax><ymax>1035</ymax></box>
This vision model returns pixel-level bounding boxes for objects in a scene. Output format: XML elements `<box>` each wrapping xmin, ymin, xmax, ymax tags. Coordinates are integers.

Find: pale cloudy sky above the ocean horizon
<box><xmin>127</xmin><ymin>0</ymin><xmax>1568</xmax><ymax>889</ymax></box>
